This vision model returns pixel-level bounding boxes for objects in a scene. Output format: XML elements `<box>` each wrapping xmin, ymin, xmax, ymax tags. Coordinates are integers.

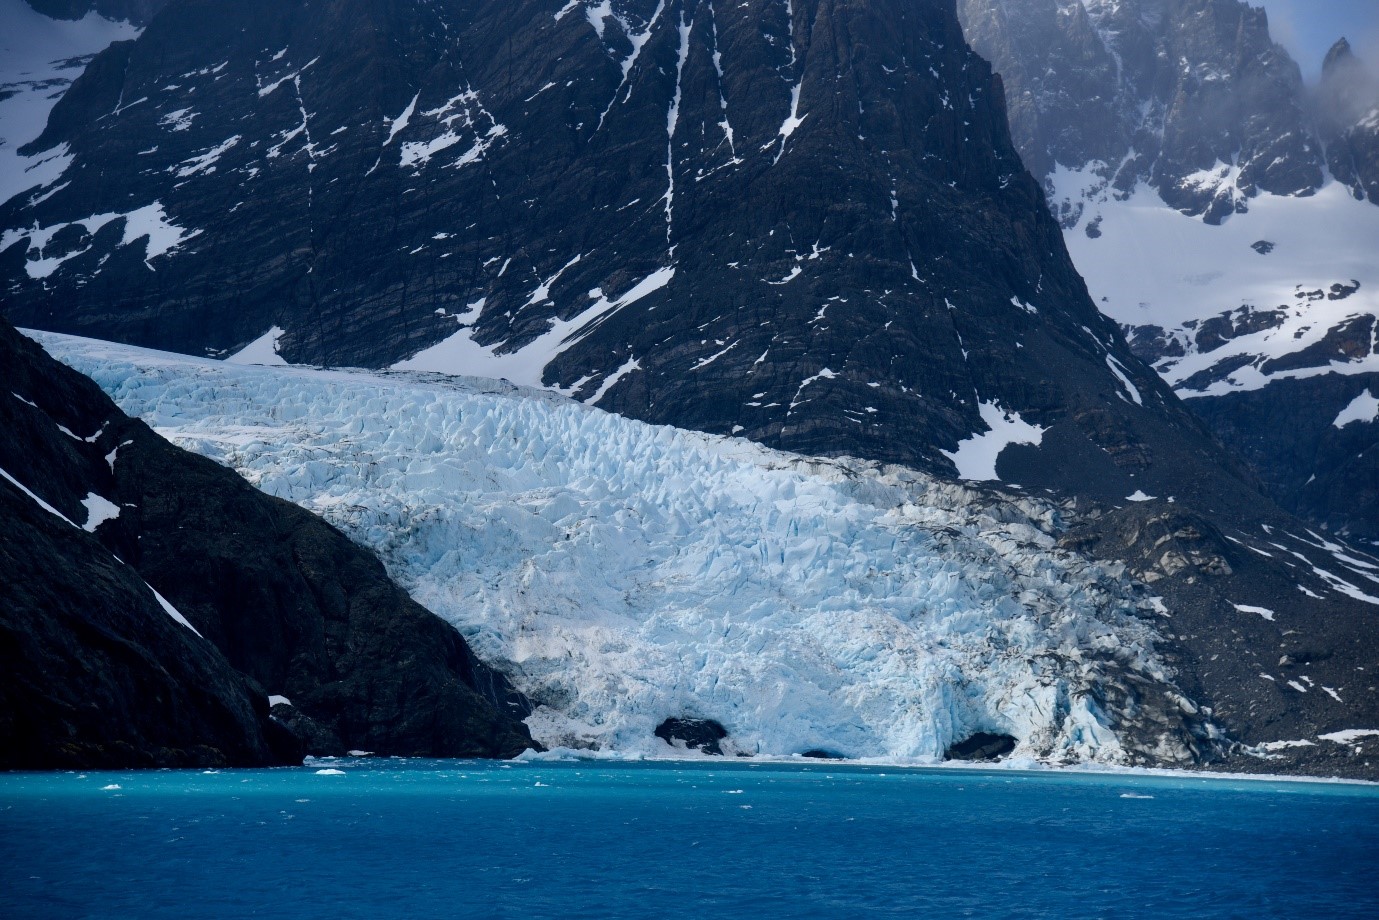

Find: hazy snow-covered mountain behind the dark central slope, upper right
<box><xmin>961</xmin><ymin>0</ymin><xmax>1379</xmax><ymax>539</ymax></box>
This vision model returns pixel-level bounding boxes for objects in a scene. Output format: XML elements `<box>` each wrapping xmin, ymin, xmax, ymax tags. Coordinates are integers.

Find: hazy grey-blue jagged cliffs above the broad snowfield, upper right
<box><xmin>958</xmin><ymin>0</ymin><xmax>1322</xmax><ymax>223</ymax></box>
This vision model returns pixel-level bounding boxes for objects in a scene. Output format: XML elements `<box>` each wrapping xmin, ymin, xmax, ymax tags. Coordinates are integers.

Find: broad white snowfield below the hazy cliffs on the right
<box><xmin>1049</xmin><ymin>163</ymin><xmax>1379</xmax><ymax>396</ymax></box>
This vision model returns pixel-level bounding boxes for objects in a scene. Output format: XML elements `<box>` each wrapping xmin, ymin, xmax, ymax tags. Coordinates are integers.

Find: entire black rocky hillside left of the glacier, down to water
<box><xmin>0</xmin><ymin>326</ymin><xmax>530</xmax><ymax>766</ymax></box>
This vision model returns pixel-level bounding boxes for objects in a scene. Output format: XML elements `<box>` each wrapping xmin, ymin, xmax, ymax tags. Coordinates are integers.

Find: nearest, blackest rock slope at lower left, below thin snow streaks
<box><xmin>0</xmin><ymin>474</ymin><xmax>293</xmax><ymax>770</ymax></box>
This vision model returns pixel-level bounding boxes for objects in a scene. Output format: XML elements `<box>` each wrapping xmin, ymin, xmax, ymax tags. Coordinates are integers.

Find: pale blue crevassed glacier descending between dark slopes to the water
<box><xmin>26</xmin><ymin>332</ymin><xmax>1209</xmax><ymax>764</ymax></box>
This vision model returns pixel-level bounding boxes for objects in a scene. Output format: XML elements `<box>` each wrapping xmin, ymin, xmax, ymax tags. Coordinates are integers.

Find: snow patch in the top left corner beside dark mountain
<box><xmin>0</xmin><ymin>0</ymin><xmax>139</xmax><ymax>203</ymax></box>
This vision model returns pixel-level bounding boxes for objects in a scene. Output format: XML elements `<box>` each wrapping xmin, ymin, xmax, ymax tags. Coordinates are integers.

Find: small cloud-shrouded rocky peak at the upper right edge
<box><xmin>1317</xmin><ymin>39</ymin><xmax>1379</xmax><ymax>203</ymax></box>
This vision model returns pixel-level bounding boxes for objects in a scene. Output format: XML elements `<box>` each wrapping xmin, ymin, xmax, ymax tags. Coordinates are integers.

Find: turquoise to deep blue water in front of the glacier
<box><xmin>0</xmin><ymin>760</ymin><xmax>1379</xmax><ymax>920</ymax></box>
